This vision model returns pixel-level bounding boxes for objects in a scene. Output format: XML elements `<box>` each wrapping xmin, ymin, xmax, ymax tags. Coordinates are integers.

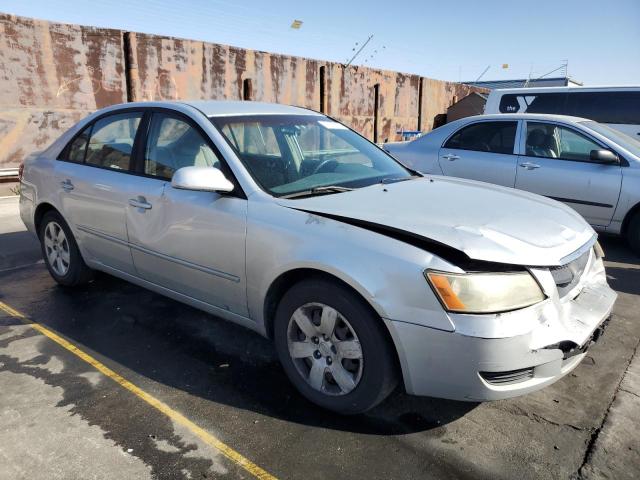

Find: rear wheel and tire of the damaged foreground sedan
<box><xmin>38</xmin><ymin>211</ymin><xmax>93</xmax><ymax>287</ymax></box>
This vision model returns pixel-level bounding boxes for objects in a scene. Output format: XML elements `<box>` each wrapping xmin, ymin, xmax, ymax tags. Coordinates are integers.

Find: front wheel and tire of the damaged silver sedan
<box><xmin>274</xmin><ymin>279</ymin><xmax>398</xmax><ymax>414</ymax></box>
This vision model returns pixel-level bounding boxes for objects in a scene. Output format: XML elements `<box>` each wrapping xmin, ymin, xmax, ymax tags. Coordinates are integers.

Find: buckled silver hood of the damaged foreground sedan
<box><xmin>278</xmin><ymin>176</ymin><xmax>595</xmax><ymax>266</ymax></box>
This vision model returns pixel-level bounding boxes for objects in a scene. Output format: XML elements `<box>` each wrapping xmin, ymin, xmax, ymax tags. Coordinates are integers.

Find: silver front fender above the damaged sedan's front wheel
<box><xmin>247</xmin><ymin>201</ymin><xmax>455</xmax><ymax>331</ymax></box>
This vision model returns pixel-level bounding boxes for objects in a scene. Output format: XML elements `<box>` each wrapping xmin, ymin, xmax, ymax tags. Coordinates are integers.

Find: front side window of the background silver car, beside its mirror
<box><xmin>526</xmin><ymin>122</ymin><xmax>602</xmax><ymax>162</ymax></box>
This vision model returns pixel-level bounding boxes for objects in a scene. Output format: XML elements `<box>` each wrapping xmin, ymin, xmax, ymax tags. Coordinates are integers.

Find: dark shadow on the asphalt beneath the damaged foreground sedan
<box><xmin>16</xmin><ymin>266</ymin><xmax>477</xmax><ymax>435</ymax></box>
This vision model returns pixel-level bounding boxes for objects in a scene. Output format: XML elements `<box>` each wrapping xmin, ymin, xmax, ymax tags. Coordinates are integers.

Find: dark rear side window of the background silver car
<box><xmin>444</xmin><ymin>122</ymin><xmax>518</xmax><ymax>154</ymax></box>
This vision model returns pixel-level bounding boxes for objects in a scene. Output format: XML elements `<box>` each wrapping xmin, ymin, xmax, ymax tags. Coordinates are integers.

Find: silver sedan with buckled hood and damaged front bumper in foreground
<box><xmin>20</xmin><ymin>102</ymin><xmax>616</xmax><ymax>413</ymax></box>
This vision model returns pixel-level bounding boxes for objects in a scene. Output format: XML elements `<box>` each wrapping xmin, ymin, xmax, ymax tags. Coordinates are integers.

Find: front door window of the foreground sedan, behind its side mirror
<box><xmin>144</xmin><ymin>113</ymin><xmax>220</xmax><ymax>180</ymax></box>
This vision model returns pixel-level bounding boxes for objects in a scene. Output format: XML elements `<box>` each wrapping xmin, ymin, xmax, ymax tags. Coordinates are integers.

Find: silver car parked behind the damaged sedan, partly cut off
<box><xmin>384</xmin><ymin>114</ymin><xmax>640</xmax><ymax>255</ymax></box>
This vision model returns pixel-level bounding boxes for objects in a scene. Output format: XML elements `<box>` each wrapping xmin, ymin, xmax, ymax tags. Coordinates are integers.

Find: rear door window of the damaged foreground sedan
<box><xmin>85</xmin><ymin>112</ymin><xmax>142</xmax><ymax>170</ymax></box>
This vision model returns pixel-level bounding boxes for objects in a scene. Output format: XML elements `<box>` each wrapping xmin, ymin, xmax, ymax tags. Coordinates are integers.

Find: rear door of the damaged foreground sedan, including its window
<box><xmin>54</xmin><ymin>110</ymin><xmax>142</xmax><ymax>273</ymax></box>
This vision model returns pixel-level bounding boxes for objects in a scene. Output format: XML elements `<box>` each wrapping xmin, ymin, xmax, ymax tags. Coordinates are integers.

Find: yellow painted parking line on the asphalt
<box><xmin>0</xmin><ymin>302</ymin><xmax>276</xmax><ymax>480</ymax></box>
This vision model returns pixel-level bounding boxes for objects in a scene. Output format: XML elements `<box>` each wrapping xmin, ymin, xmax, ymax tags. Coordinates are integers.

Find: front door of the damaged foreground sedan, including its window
<box><xmin>127</xmin><ymin>111</ymin><xmax>247</xmax><ymax>316</ymax></box>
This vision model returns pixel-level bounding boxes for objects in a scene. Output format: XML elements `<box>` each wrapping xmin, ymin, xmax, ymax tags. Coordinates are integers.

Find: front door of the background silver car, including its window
<box><xmin>516</xmin><ymin>121</ymin><xmax>622</xmax><ymax>227</ymax></box>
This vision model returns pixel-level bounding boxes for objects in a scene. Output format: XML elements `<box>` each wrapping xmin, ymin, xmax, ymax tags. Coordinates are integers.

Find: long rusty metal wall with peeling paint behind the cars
<box><xmin>0</xmin><ymin>14</ymin><xmax>482</xmax><ymax>169</ymax></box>
